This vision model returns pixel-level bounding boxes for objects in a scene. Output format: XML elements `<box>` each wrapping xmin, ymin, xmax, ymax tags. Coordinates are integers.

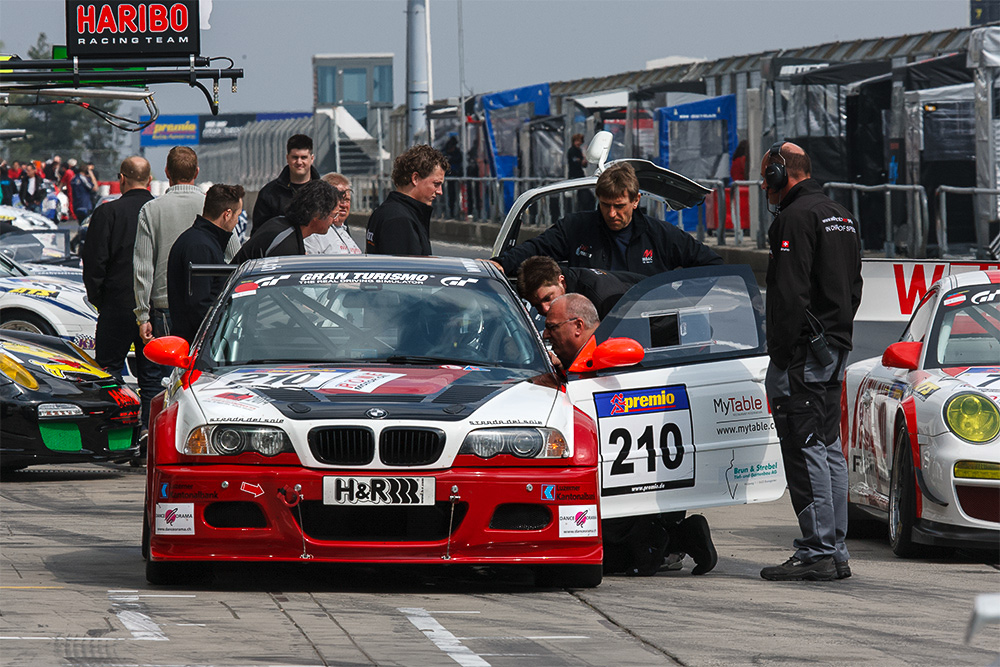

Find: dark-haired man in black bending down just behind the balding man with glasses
<box><xmin>517</xmin><ymin>255</ymin><xmax>647</xmax><ymax>320</ymax></box>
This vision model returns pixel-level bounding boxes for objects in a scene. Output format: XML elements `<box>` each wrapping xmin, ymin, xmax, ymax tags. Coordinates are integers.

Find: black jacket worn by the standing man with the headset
<box><xmin>766</xmin><ymin>178</ymin><xmax>861</xmax><ymax>368</ymax></box>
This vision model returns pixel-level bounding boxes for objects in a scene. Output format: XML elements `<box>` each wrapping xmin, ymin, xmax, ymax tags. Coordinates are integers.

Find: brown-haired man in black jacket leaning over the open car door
<box><xmin>494</xmin><ymin>163</ymin><xmax>722</xmax><ymax>276</ymax></box>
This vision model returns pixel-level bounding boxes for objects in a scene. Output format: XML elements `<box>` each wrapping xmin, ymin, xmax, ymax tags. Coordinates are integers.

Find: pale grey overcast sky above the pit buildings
<box><xmin>0</xmin><ymin>0</ymin><xmax>969</xmax><ymax>114</ymax></box>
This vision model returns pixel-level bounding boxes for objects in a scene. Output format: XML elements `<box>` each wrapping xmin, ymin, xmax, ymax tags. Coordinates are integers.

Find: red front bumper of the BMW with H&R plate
<box><xmin>146</xmin><ymin>465</ymin><xmax>603</xmax><ymax>564</ymax></box>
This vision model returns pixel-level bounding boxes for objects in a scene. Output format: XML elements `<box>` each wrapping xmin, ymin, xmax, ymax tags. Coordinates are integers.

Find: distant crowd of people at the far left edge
<box><xmin>0</xmin><ymin>155</ymin><xmax>100</xmax><ymax>222</ymax></box>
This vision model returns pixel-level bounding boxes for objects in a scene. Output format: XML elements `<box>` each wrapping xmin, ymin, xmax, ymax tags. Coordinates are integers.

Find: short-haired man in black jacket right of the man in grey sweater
<box><xmin>167</xmin><ymin>183</ymin><xmax>244</xmax><ymax>343</ymax></box>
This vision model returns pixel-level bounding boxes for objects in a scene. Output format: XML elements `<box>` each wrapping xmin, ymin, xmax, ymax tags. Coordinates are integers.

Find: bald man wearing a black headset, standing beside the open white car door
<box><xmin>760</xmin><ymin>141</ymin><xmax>861</xmax><ymax>581</ymax></box>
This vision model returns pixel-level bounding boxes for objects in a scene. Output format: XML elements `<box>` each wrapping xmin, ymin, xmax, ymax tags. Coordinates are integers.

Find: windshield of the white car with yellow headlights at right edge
<box><xmin>924</xmin><ymin>285</ymin><xmax>1000</xmax><ymax>368</ymax></box>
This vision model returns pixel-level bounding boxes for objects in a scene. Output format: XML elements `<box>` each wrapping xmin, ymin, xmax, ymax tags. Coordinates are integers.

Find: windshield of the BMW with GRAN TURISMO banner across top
<box><xmin>200</xmin><ymin>273</ymin><xmax>548</xmax><ymax>372</ymax></box>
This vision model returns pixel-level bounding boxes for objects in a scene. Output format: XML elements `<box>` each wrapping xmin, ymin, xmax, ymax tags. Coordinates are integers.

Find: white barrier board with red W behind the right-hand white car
<box><xmin>854</xmin><ymin>259</ymin><xmax>1000</xmax><ymax>323</ymax></box>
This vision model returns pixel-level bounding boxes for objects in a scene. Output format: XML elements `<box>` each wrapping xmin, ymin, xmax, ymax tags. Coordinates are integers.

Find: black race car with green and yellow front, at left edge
<box><xmin>0</xmin><ymin>331</ymin><xmax>139</xmax><ymax>472</ymax></box>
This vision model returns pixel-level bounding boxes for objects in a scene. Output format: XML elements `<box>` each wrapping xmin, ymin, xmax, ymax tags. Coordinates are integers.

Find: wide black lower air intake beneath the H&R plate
<box><xmin>289</xmin><ymin>500</ymin><xmax>469</xmax><ymax>542</ymax></box>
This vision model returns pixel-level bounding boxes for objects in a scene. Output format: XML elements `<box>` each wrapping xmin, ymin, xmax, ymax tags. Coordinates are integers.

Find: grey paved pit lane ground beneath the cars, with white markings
<box><xmin>0</xmin><ymin>465</ymin><xmax>1000</xmax><ymax>667</ymax></box>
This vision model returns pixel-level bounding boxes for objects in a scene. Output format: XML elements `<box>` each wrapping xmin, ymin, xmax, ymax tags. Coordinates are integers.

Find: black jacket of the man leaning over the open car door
<box><xmin>495</xmin><ymin>209</ymin><xmax>722</xmax><ymax>276</ymax></box>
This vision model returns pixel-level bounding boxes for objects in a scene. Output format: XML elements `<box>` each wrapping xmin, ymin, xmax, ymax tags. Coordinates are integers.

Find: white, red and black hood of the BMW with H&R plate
<box><xmin>192</xmin><ymin>365</ymin><xmax>556</xmax><ymax>424</ymax></box>
